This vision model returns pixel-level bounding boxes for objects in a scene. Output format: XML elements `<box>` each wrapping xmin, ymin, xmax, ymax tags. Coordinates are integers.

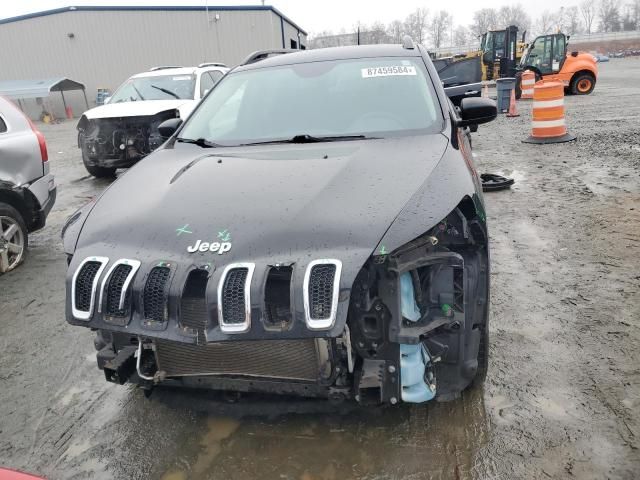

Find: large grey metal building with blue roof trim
<box><xmin>0</xmin><ymin>5</ymin><xmax>307</xmax><ymax>117</ymax></box>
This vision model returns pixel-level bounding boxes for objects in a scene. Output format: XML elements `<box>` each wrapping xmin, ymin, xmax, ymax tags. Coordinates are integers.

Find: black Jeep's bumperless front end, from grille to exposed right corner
<box><xmin>69</xmin><ymin>197</ymin><xmax>489</xmax><ymax>405</ymax></box>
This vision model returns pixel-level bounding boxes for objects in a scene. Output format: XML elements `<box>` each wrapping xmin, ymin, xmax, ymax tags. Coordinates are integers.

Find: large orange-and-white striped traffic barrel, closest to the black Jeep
<box><xmin>523</xmin><ymin>82</ymin><xmax>576</xmax><ymax>143</ymax></box>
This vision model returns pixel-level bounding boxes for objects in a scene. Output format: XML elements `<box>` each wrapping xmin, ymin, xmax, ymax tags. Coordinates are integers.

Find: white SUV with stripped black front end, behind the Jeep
<box><xmin>78</xmin><ymin>63</ymin><xmax>229</xmax><ymax>177</ymax></box>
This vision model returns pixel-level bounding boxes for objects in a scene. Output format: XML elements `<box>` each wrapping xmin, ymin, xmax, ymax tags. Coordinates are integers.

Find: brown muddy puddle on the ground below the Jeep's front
<box><xmin>150</xmin><ymin>389</ymin><xmax>489</xmax><ymax>480</ymax></box>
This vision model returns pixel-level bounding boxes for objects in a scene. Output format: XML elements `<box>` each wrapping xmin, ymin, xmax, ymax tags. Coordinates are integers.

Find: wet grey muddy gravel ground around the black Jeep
<box><xmin>0</xmin><ymin>58</ymin><xmax>640</xmax><ymax>480</ymax></box>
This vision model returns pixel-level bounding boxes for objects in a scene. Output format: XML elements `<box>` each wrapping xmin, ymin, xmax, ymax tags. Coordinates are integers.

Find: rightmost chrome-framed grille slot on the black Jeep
<box><xmin>304</xmin><ymin>259</ymin><xmax>342</xmax><ymax>330</ymax></box>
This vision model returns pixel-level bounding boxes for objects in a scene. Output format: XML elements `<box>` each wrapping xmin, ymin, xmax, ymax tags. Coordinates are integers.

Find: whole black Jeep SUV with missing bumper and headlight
<box><xmin>64</xmin><ymin>38</ymin><xmax>496</xmax><ymax>404</ymax></box>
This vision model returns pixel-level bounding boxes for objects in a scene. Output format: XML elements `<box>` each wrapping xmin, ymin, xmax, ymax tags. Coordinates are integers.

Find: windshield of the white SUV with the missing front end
<box><xmin>109</xmin><ymin>74</ymin><xmax>196</xmax><ymax>103</ymax></box>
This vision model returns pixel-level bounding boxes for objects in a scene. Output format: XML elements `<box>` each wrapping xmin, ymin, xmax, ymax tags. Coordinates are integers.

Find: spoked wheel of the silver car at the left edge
<box><xmin>0</xmin><ymin>203</ymin><xmax>28</xmax><ymax>274</ymax></box>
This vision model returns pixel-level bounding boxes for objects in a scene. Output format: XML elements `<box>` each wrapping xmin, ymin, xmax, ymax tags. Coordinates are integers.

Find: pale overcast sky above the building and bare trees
<box><xmin>0</xmin><ymin>0</ymin><xmax>578</xmax><ymax>34</ymax></box>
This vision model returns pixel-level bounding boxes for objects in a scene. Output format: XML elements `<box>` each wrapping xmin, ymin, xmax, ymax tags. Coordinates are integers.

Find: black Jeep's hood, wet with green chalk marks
<box><xmin>78</xmin><ymin>134</ymin><xmax>447</xmax><ymax>264</ymax></box>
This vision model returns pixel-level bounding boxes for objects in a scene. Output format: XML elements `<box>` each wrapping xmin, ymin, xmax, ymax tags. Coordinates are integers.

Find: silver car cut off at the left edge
<box><xmin>0</xmin><ymin>97</ymin><xmax>56</xmax><ymax>274</ymax></box>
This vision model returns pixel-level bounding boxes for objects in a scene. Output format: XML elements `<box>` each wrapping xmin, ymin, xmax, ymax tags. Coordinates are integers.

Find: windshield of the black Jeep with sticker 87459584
<box><xmin>180</xmin><ymin>57</ymin><xmax>442</xmax><ymax>145</ymax></box>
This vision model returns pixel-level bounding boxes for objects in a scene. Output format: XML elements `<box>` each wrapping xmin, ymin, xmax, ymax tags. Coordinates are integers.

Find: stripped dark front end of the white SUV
<box><xmin>77</xmin><ymin>109</ymin><xmax>180</xmax><ymax>169</ymax></box>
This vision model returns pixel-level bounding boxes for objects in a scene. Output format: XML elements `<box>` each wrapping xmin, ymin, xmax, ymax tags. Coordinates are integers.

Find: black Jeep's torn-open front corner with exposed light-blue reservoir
<box><xmin>349</xmin><ymin>200</ymin><xmax>489</xmax><ymax>403</ymax></box>
